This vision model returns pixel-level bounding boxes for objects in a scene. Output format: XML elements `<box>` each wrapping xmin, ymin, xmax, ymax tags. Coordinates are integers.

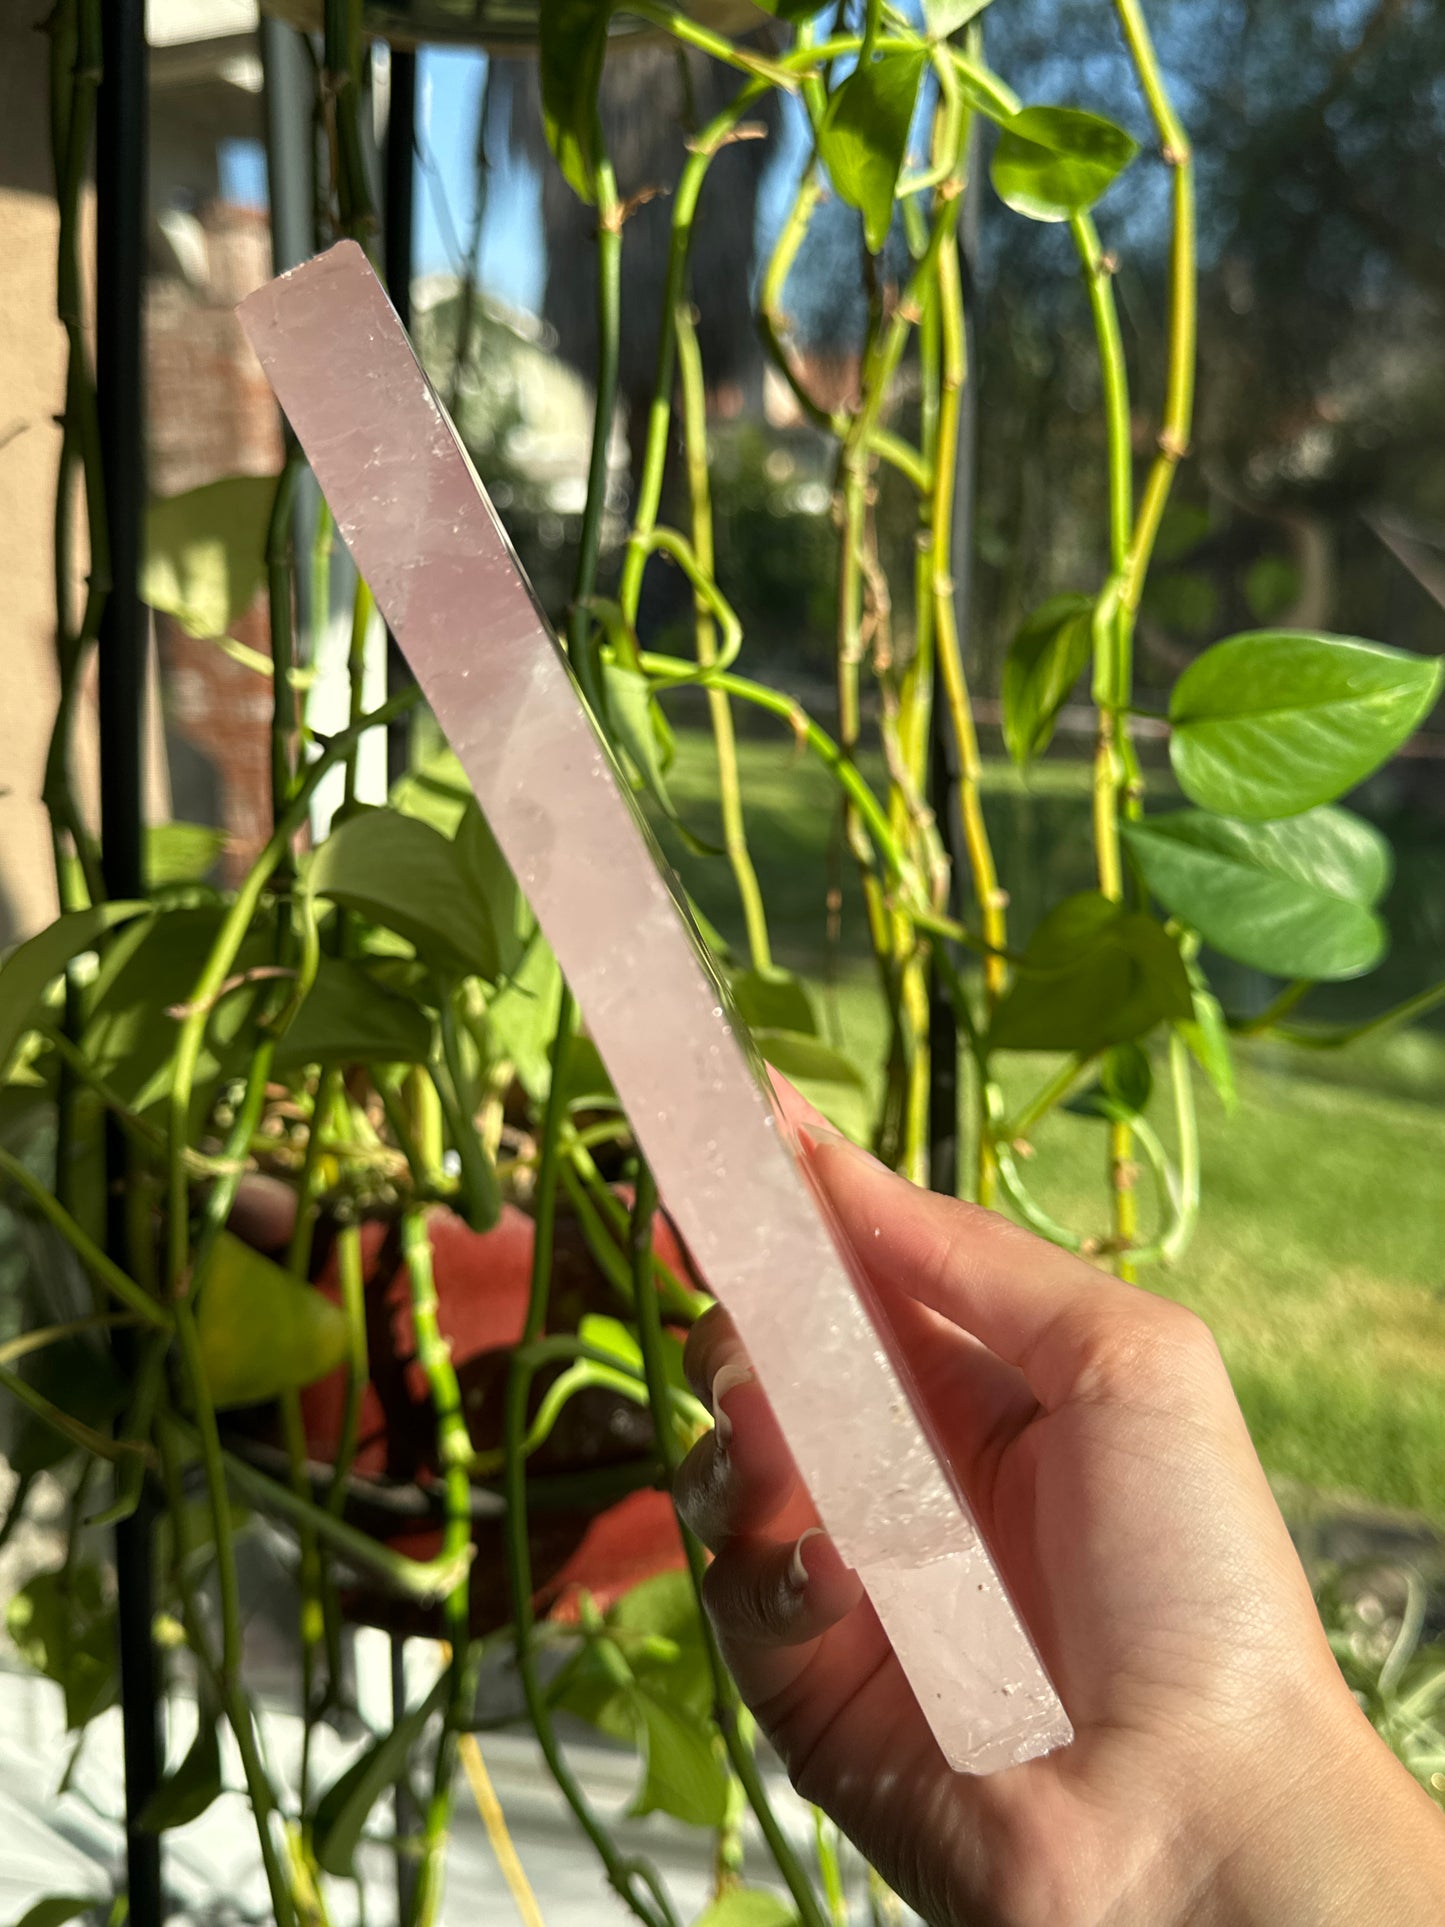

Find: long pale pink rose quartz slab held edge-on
<box><xmin>241</xmin><ymin>243</ymin><xmax>1071</xmax><ymax>1773</ymax></box>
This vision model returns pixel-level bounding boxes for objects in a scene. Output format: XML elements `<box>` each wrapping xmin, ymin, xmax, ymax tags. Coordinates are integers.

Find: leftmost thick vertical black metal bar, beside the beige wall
<box><xmin>94</xmin><ymin>0</ymin><xmax>162</xmax><ymax>1927</ymax></box>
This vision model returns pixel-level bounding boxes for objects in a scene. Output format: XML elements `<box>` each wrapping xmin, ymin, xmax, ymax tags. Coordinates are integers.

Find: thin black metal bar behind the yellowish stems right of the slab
<box><xmin>929</xmin><ymin>121</ymin><xmax>983</xmax><ymax>1197</ymax></box>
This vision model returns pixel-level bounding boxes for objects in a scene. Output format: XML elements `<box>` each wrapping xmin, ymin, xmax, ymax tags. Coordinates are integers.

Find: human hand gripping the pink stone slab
<box><xmin>676</xmin><ymin>1093</ymin><xmax>1445</xmax><ymax>1927</ymax></box>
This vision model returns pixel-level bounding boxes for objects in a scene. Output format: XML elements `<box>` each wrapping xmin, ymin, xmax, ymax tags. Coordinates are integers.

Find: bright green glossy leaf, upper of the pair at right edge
<box><xmin>1169</xmin><ymin>630</ymin><xmax>1445</xmax><ymax>823</ymax></box>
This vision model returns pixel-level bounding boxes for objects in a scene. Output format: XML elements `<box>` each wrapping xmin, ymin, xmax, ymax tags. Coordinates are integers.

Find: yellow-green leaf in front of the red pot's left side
<box><xmin>195</xmin><ymin>1231</ymin><xmax>347</xmax><ymax>1409</ymax></box>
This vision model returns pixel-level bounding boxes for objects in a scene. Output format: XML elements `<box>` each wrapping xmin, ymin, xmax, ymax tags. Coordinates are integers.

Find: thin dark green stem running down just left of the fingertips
<box><xmin>630</xmin><ymin>1158</ymin><xmax>828</xmax><ymax>1927</ymax></box>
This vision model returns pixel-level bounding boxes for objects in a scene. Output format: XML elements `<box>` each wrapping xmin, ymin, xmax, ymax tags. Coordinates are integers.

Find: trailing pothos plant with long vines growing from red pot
<box><xmin>0</xmin><ymin>0</ymin><xmax>1441</xmax><ymax>1927</ymax></box>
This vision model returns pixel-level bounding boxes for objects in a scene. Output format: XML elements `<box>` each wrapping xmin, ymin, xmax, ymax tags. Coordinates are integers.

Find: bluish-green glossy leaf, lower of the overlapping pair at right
<box><xmin>1123</xmin><ymin>809</ymin><xmax>1391</xmax><ymax>979</ymax></box>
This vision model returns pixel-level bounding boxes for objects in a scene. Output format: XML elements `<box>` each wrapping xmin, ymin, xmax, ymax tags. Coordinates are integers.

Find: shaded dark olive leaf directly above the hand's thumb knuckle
<box><xmin>990</xmin><ymin>890</ymin><xmax>1193</xmax><ymax>1056</ymax></box>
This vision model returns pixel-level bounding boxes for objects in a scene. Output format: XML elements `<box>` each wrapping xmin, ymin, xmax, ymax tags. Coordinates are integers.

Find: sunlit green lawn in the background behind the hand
<box><xmin>651</xmin><ymin>730</ymin><xmax>1445</xmax><ymax>1520</ymax></box>
